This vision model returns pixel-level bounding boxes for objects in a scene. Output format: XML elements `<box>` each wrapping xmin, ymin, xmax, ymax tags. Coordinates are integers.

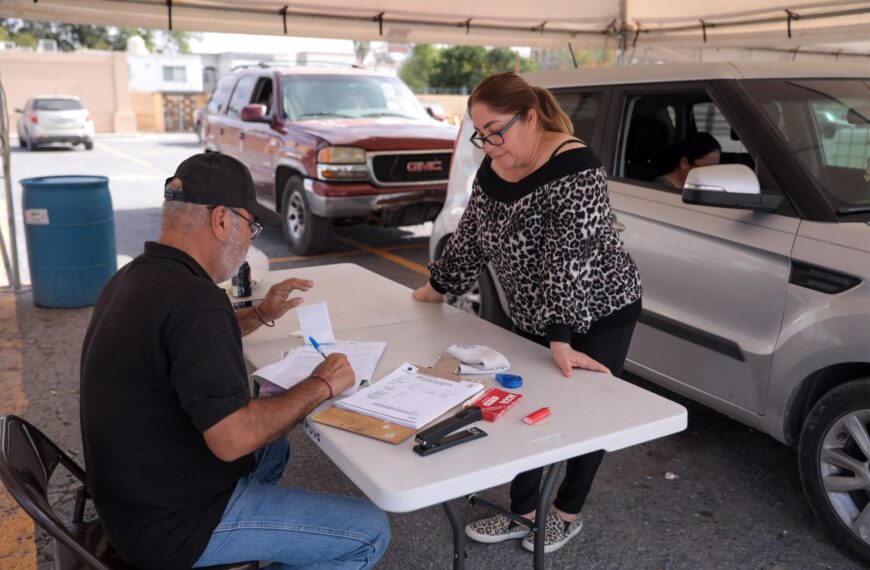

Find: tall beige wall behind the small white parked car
<box><xmin>0</xmin><ymin>51</ymin><xmax>136</xmax><ymax>133</ymax></box>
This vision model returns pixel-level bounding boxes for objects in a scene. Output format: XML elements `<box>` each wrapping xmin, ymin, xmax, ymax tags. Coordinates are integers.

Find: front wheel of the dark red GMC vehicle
<box><xmin>281</xmin><ymin>176</ymin><xmax>332</xmax><ymax>255</ymax></box>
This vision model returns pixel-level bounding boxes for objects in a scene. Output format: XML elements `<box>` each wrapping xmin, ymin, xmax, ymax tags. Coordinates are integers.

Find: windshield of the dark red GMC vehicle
<box><xmin>281</xmin><ymin>75</ymin><xmax>429</xmax><ymax>121</ymax></box>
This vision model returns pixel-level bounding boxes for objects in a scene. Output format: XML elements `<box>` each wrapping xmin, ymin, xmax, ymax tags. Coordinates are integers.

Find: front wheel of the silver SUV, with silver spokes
<box><xmin>800</xmin><ymin>378</ymin><xmax>870</xmax><ymax>562</ymax></box>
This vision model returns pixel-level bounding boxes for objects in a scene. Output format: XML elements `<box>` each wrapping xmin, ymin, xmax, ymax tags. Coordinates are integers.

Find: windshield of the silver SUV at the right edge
<box><xmin>743</xmin><ymin>79</ymin><xmax>870</xmax><ymax>217</ymax></box>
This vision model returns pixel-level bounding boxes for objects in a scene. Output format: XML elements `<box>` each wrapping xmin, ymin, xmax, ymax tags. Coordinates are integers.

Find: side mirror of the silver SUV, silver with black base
<box><xmin>683</xmin><ymin>164</ymin><xmax>783</xmax><ymax>212</ymax></box>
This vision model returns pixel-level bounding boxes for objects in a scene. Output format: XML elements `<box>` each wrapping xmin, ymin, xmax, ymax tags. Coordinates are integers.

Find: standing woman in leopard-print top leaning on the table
<box><xmin>414</xmin><ymin>73</ymin><xmax>641</xmax><ymax>552</ymax></box>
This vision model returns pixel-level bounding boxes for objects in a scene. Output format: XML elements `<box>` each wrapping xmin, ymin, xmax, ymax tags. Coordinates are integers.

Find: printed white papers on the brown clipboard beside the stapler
<box><xmin>335</xmin><ymin>362</ymin><xmax>483</xmax><ymax>429</ymax></box>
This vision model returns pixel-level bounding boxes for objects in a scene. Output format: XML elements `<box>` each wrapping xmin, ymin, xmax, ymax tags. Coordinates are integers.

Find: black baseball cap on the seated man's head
<box><xmin>163</xmin><ymin>152</ymin><xmax>281</xmax><ymax>226</ymax></box>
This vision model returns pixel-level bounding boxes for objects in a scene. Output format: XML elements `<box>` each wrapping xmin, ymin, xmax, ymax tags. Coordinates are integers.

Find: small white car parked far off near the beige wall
<box><xmin>15</xmin><ymin>95</ymin><xmax>94</xmax><ymax>150</ymax></box>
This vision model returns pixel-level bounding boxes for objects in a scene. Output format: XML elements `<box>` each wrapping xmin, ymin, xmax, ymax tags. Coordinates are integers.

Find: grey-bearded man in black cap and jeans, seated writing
<box><xmin>81</xmin><ymin>154</ymin><xmax>390</xmax><ymax>570</ymax></box>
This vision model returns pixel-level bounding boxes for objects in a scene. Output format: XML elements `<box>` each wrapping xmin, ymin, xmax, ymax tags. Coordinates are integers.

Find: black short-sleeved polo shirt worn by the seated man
<box><xmin>81</xmin><ymin>242</ymin><xmax>254</xmax><ymax>570</ymax></box>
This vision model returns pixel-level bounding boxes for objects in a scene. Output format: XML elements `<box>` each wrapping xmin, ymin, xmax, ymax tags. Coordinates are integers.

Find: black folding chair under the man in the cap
<box><xmin>0</xmin><ymin>414</ymin><xmax>258</xmax><ymax>570</ymax></box>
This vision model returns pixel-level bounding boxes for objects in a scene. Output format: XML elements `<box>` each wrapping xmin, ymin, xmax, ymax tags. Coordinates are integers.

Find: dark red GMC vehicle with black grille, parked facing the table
<box><xmin>202</xmin><ymin>65</ymin><xmax>457</xmax><ymax>254</ymax></box>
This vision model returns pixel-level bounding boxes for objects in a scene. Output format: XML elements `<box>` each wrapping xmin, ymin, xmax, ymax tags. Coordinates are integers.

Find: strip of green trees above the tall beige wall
<box><xmin>0</xmin><ymin>19</ymin><xmax>195</xmax><ymax>53</ymax></box>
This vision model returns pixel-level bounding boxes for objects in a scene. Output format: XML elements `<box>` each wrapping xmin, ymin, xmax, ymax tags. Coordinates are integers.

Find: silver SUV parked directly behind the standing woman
<box><xmin>430</xmin><ymin>62</ymin><xmax>870</xmax><ymax>561</ymax></box>
